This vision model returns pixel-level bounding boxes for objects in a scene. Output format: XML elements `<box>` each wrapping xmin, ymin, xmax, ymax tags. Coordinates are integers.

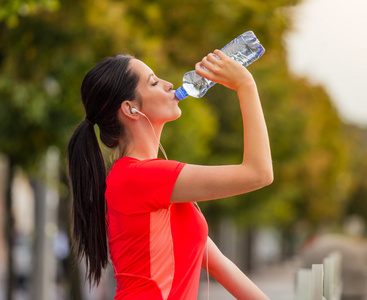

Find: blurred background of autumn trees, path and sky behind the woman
<box><xmin>0</xmin><ymin>0</ymin><xmax>367</xmax><ymax>300</ymax></box>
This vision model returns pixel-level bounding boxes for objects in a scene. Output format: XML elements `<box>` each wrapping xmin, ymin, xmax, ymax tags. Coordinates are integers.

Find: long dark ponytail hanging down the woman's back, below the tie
<box><xmin>68</xmin><ymin>119</ymin><xmax>108</xmax><ymax>285</ymax></box>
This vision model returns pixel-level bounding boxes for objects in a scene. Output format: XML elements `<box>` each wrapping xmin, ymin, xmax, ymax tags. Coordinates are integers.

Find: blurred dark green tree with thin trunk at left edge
<box><xmin>0</xmin><ymin>1</ymin><xmax>85</xmax><ymax>299</ymax></box>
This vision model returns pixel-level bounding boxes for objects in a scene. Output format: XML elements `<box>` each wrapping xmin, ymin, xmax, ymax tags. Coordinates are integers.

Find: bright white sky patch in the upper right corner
<box><xmin>285</xmin><ymin>0</ymin><xmax>367</xmax><ymax>127</ymax></box>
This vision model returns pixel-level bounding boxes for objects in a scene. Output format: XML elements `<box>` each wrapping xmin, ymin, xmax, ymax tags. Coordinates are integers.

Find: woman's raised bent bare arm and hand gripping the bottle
<box><xmin>171</xmin><ymin>50</ymin><xmax>273</xmax><ymax>202</ymax></box>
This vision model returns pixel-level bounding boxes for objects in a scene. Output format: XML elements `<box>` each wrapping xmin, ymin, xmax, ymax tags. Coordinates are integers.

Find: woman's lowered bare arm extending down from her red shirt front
<box><xmin>202</xmin><ymin>237</ymin><xmax>269</xmax><ymax>300</ymax></box>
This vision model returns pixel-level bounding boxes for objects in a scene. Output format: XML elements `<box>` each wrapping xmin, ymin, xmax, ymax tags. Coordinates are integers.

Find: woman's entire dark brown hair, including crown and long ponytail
<box><xmin>68</xmin><ymin>54</ymin><xmax>139</xmax><ymax>285</ymax></box>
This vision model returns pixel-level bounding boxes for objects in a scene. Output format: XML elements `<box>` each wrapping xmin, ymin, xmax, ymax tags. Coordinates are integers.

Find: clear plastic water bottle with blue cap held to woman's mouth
<box><xmin>175</xmin><ymin>31</ymin><xmax>265</xmax><ymax>100</ymax></box>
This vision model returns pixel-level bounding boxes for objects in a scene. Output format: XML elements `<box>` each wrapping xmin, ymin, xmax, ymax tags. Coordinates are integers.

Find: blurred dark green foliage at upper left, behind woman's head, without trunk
<box><xmin>0</xmin><ymin>0</ymin><xmax>90</xmax><ymax>167</ymax></box>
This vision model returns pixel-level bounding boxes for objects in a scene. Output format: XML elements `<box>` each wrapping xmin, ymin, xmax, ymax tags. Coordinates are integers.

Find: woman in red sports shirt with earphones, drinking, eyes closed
<box><xmin>68</xmin><ymin>50</ymin><xmax>273</xmax><ymax>300</ymax></box>
